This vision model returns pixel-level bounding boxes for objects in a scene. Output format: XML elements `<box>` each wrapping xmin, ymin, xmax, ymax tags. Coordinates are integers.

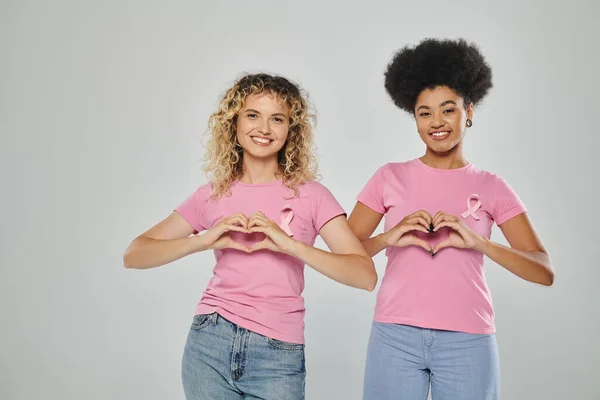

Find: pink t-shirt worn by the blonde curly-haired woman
<box><xmin>175</xmin><ymin>181</ymin><xmax>345</xmax><ymax>343</ymax></box>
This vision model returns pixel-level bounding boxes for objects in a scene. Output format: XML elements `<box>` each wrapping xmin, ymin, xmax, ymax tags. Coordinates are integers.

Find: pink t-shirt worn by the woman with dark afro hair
<box><xmin>358</xmin><ymin>159</ymin><xmax>526</xmax><ymax>333</ymax></box>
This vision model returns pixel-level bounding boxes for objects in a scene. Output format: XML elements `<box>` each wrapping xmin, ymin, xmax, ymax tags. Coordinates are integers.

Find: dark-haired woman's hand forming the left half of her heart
<box><xmin>381</xmin><ymin>210</ymin><xmax>433</xmax><ymax>252</ymax></box>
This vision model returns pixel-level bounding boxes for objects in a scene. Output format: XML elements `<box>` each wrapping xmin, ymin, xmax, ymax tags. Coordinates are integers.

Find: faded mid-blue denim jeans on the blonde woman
<box><xmin>182</xmin><ymin>313</ymin><xmax>306</xmax><ymax>400</ymax></box>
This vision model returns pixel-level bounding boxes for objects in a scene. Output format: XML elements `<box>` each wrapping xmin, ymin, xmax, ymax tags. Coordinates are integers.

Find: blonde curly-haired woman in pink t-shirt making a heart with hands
<box><xmin>124</xmin><ymin>74</ymin><xmax>377</xmax><ymax>400</ymax></box>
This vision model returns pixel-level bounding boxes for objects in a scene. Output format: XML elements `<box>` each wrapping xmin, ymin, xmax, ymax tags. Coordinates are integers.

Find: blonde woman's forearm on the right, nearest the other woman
<box><xmin>287</xmin><ymin>241</ymin><xmax>377</xmax><ymax>291</ymax></box>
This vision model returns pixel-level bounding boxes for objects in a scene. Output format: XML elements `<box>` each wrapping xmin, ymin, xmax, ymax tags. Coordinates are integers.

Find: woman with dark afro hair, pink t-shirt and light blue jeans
<box><xmin>349</xmin><ymin>39</ymin><xmax>554</xmax><ymax>400</ymax></box>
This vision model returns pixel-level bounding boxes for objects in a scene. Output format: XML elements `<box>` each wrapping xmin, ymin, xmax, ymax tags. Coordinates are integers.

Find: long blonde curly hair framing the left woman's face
<box><xmin>204</xmin><ymin>74</ymin><xmax>317</xmax><ymax>199</ymax></box>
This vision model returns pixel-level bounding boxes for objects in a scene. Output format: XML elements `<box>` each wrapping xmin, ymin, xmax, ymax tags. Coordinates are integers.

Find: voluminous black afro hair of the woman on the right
<box><xmin>385</xmin><ymin>39</ymin><xmax>492</xmax><ymax>114</ymax></box>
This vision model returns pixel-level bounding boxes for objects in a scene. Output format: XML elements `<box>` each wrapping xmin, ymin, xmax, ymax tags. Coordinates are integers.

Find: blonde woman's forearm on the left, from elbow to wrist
<box><xmin>123</xmin><ymin>235</ymin><xmax>208</xmax><ymax>269</ymax></box>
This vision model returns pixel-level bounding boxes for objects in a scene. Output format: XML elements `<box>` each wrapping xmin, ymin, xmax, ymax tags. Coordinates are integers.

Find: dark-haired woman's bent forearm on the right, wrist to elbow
<box><xmin>476</xmin><ymin>238</ymin><xmax>554</xmax><ymax>286</ymax></box>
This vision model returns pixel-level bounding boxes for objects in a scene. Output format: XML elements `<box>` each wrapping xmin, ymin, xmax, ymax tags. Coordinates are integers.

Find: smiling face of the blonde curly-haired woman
<box><xmin>236</xmin><ymin>92</ymin><xmax>290</xmax><ymax>161</ymax></box>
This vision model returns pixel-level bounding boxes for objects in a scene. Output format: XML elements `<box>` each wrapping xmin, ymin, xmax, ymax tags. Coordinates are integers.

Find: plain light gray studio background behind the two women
<box><xmin>0</xmin><ymin>0</ymin><xmax>600</xmax><ymax>400</ymax></box>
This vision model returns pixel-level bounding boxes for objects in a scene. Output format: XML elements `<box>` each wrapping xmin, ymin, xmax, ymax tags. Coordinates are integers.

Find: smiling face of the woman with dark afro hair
<box><xmin>415</xmin><ymin>86</ymin><xmax>473</xmax><ymax>155</ymax></box>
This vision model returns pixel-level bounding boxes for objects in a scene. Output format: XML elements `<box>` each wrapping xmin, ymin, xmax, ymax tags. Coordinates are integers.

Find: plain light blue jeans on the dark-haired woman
<box><xmin>363</xmin><ymin>321</ymin><xmax>500</xmax><ymax>400</ymax></box>
